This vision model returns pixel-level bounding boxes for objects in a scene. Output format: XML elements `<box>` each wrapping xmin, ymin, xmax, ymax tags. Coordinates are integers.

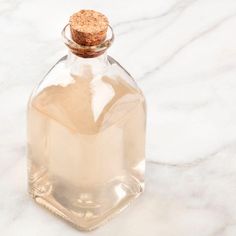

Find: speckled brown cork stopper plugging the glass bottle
<box><xmin>69</xmin><ymin>10</ymin><xmax>109</xmax><ymax>46</ymax></box>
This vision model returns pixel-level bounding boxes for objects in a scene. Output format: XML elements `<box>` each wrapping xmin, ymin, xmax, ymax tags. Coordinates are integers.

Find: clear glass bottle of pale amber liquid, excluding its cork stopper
<box><xmin>28</xmin><ymin>11</ymin><xmax>146</xmax><ymax>230</ymax></box>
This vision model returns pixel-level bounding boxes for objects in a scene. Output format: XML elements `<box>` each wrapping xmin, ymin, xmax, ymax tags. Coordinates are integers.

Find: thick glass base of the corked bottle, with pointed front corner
<box><xmin>29</xmin><ymin>173</ymin><xmax>143</xmax><ymax>231</ymax></box>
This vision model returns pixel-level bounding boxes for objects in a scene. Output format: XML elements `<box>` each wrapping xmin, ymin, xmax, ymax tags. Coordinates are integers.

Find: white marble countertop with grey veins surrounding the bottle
<box><xmin>0</xmin><ymin>0</ymin><xmax>236</xmax><ymax>236</ymax></box>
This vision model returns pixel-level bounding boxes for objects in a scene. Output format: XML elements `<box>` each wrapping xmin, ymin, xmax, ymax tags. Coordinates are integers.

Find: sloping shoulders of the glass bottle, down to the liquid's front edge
<box><xmin>29</xmin><ymin>54</ymin><xmax>145</xmax><ymax>134</ymax></box>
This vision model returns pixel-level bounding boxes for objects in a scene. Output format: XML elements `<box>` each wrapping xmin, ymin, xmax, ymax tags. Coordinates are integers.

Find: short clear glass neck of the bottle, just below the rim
<box><xmin>67</xmin><ymin>50</ymin><xmax>109</xmax><ymax>77</ymax></box>
